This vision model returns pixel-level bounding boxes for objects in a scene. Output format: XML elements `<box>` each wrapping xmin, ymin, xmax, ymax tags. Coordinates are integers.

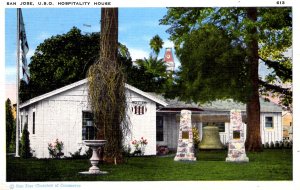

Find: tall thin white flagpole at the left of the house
<box><xmin>15</xmin><ymin>8</ymin><xmax>20</xmax><ymax>157</ymax></box>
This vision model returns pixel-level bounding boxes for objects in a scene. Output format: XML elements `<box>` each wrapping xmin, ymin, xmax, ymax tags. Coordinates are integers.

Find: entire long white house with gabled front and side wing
<box><xmin>20</xmin><ymin>79</ymin><xmax>282</xmax><ymax>158</ymax></box>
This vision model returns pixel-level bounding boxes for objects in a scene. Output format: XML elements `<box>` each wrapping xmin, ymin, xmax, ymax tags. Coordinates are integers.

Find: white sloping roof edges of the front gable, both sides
<box><xmin>20</xmin><ymin>79</ymin><xmax>167</xmax><ymax>108</ymax></box>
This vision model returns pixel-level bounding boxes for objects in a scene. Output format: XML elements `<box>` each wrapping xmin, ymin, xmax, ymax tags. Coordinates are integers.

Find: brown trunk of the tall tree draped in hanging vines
<box><xmin>98</xmin><ymin>8</ymin><xmax>124</xmax><ymax>164</ymax></box>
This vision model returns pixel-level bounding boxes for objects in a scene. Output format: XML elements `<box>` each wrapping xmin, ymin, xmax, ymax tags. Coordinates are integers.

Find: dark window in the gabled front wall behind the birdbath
<box><xmin>82</xmin><ymin>112</ymin><xmax>97</xmax><ymax>140</ymax></box>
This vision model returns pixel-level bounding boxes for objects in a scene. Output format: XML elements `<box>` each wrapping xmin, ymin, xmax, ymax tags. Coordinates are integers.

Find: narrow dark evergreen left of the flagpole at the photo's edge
<box><xmin>5</xmin><ymin>98</ymin><xmax>15</xmax><ymax>152</ymax></box>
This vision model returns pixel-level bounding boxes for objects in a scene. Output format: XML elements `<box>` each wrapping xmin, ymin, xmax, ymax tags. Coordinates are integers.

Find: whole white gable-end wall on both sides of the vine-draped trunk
<box><xmin>21</xmin><ymin>84</ymin><xmax>156</xmax><ymax>158</ymax></box>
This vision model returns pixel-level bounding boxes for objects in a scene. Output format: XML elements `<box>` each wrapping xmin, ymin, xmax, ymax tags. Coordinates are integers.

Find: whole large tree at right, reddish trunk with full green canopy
<box><xmin>161</xmin><ymin>7</ymin><xmax>291</xmax><ymax>151</ymax></box>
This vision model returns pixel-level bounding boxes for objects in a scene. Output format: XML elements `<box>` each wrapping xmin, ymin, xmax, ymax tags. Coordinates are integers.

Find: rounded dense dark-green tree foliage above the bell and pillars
<box><xmin>175</xmin><ymin>25</ymin><xmax>249</xmax><ymax>103</ymax></box>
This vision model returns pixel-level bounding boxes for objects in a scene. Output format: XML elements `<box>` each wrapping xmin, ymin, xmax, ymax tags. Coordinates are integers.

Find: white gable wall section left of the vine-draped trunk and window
<box><xmin>22</xmin><ymin>85</ymin><xmax>87</xmax><ymax>158</ymax></box>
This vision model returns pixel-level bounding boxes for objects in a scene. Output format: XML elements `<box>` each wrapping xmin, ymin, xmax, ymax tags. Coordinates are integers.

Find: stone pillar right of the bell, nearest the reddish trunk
<box><xmin>226</xmin><ymin>110</ymin><xmax>249</xmax><ymax>162</ymax></box>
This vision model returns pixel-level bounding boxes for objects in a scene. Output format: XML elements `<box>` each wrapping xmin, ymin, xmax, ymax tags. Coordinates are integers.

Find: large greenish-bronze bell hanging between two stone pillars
<box><xmin>199</xmin><ymin>126</ymin><xmax>224</xmax><ymax>149</ymax></box>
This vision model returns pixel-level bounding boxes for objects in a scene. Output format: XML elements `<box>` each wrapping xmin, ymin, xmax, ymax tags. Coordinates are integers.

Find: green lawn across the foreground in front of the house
<box><xmin>7</xmin><ymin>149</ymin><xmax>293</xmax><ymax>181</ymax></box>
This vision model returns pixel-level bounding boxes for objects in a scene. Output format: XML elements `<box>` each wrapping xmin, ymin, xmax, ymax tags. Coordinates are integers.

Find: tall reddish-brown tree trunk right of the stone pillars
<box><xmin>245</xmin><ymin>8</ymin><xmax>262</xmax><ymax>151</ymax></box>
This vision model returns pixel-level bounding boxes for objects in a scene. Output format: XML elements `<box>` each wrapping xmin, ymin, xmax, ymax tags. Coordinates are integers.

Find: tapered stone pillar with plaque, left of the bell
<box><xmin>174</xmin><ymin>110</ymin><xmax>196</xmax><ymax>161</ymax></box>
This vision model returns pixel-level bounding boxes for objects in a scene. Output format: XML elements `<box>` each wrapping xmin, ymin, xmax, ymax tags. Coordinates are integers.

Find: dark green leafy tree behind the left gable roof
<box><xmin>20</xmin><ymin>27</ymin><xmax>132</xmax><ymax>102</ymax></box>
